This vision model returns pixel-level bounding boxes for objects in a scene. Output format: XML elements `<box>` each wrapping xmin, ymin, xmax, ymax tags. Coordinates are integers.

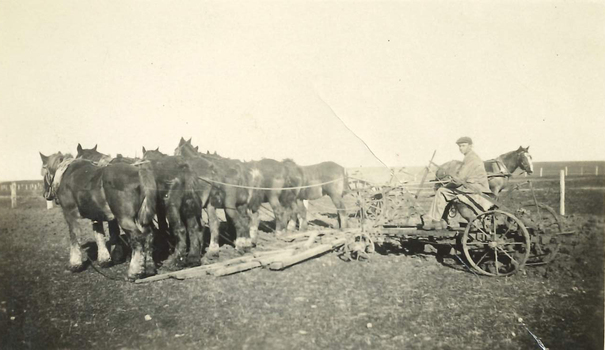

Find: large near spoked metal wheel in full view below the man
<box><xmin>461</xmin><ymin>210</ymin><xmax>530</xmax><ymax>276</ymax></box>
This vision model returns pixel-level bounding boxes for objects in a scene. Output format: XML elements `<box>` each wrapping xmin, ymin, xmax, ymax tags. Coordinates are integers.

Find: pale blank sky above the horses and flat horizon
<box><xmin>0</xmin><ymin>0</ymin><xmax>605</xmax><ymax>181</ymax></box>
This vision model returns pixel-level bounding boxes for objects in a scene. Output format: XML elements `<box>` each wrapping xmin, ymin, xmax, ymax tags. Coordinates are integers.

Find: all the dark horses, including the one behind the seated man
<box><xmin>40</xmin><ymin>138</ymin><xmax>533</xmax><ymax>279</ymax></box>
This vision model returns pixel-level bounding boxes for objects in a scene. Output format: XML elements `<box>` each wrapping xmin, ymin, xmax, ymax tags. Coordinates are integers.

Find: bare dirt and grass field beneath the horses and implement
<box><xmin>0</xmin><ymin>177</ymin><xmax>605</xmax><ymax>349</ymax></box>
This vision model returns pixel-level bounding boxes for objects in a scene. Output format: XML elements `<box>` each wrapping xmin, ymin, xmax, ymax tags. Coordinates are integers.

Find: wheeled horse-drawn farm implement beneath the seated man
<box><xmin>346</xmin><ymin>152</ymin><xmax>570</xmax><ymax>276</ymax></box>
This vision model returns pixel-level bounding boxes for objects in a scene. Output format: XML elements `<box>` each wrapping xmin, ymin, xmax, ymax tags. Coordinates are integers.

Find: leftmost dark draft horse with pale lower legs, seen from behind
<box><xmin>40</xmin><ymin>152</ymin><xmax>156</xmax><ymax>279</ymax></box>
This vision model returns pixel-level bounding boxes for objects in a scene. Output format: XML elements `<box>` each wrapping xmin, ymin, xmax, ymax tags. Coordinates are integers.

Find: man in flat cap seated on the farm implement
<box><xmin>422</xmin><ymin>136</ymin><xmax>491</xmax><ymax>230</ymax></box>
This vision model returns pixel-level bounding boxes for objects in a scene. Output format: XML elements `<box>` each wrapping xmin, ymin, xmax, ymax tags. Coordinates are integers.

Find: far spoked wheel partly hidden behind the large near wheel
<box><xmin>516</xmin><ymin>203</ymin><xmax>563</xmax><ymax>266</ymax></box>
